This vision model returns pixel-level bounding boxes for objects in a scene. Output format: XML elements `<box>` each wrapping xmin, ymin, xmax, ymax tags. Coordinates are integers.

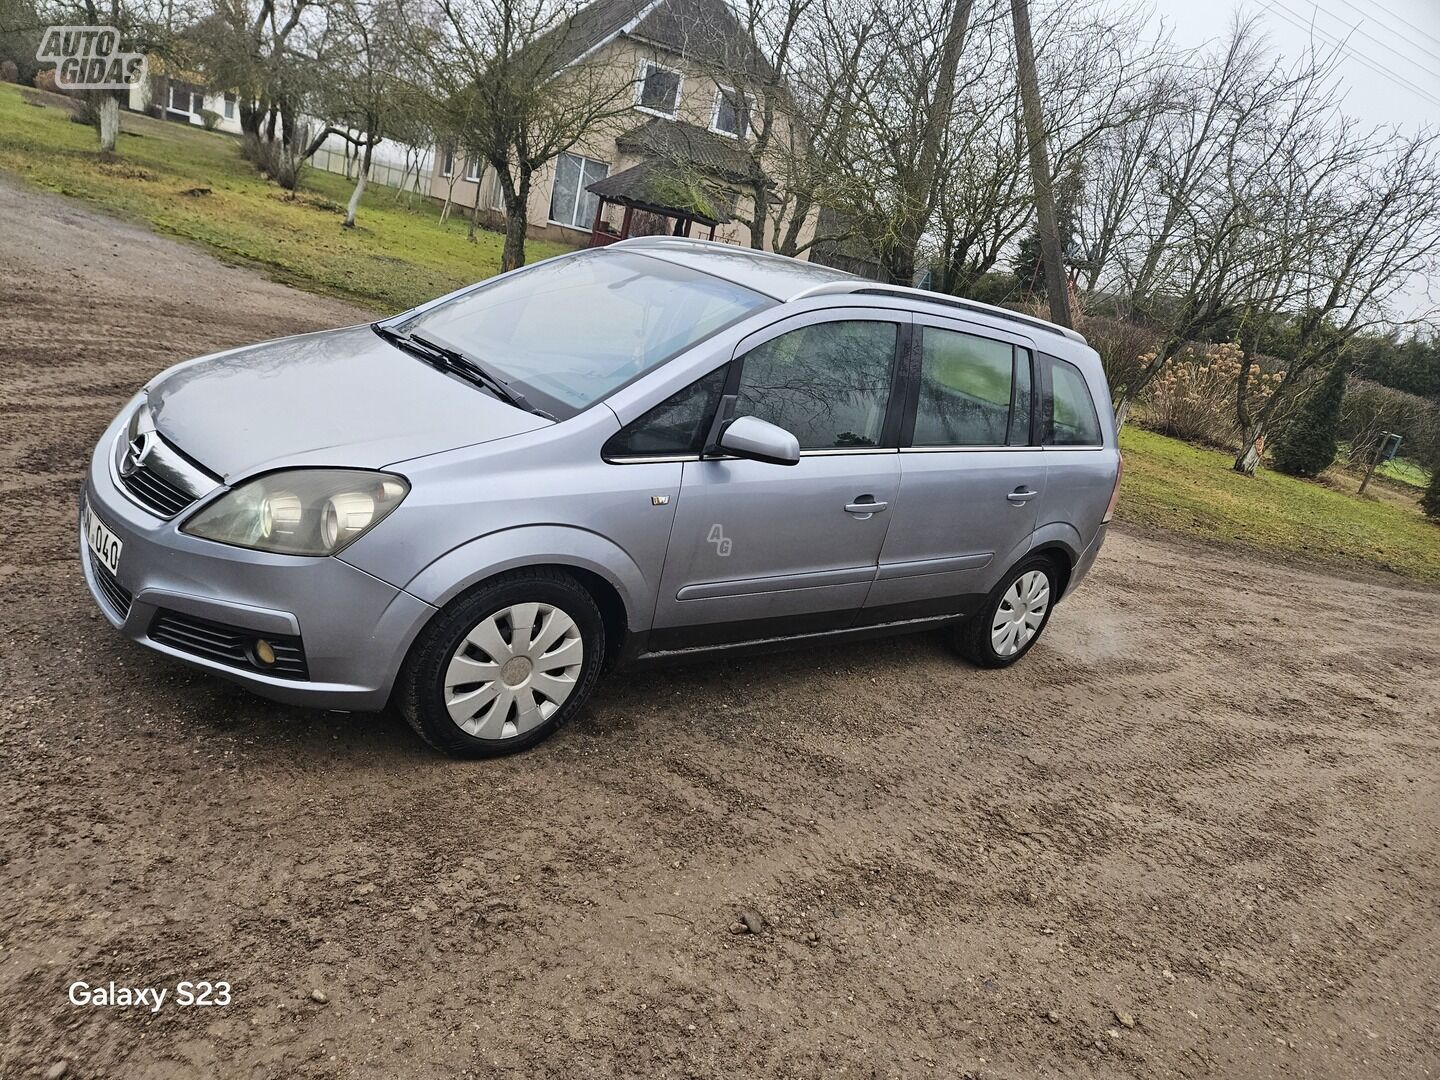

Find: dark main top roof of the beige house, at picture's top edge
<box><xmin>541</xmin><ymin>0</ymin><xmax>773</xmax><ymax>78</ymax></box>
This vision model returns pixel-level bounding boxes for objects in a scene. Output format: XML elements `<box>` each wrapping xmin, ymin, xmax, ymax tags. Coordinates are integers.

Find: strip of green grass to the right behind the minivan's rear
<box><xmin>1116</xmin><ymin>425</ymin><xmax>1440</xmax><ymax>583</ymax></box>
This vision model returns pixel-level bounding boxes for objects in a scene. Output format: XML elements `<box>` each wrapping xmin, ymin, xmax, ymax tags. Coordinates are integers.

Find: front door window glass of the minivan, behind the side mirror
<box><xmin>736</xmin><ymin>321</ymin><xmax>897</xmax><ymax>449</ymax></box>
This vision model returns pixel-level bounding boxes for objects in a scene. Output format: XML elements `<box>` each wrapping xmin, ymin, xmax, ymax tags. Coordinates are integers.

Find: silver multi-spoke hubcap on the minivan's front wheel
<box><xmin>445</xmin><ymin>603</ymin><xmax>585</xmax><ymax>739</ymax></box>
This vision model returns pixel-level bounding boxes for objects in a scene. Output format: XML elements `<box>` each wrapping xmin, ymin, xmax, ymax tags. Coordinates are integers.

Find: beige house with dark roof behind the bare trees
<box><xmin>429</xmin><ymin>0</ymin><xmax>815</xmax><ymax>256</ymax></box>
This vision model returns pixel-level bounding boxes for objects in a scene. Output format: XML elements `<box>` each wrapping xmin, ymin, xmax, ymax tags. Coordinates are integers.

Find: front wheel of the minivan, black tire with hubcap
<box><xmin>396</xmin><ymin>569</ymin><xmax>605</xmax><ymax>757</ymax></box>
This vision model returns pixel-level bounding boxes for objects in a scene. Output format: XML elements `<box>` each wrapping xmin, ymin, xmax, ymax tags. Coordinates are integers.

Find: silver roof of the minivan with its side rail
<box><xmin>606</xmin><ymin>236</ymin><xmax>1086</xmax><ymax>344</ymax></box>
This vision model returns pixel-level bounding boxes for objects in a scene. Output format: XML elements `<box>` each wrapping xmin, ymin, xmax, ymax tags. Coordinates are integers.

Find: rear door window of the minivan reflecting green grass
<box><xmin>912</xmin><ymin>327</ymin><xmax>1015</xmax><ymax>446</ymax></box>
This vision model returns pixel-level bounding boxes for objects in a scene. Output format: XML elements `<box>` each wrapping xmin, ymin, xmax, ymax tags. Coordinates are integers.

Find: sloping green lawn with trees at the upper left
<box><xmin>0</xmin><ymin>84</ymin><xmax>569</xmax><ymax>311</ymax></box>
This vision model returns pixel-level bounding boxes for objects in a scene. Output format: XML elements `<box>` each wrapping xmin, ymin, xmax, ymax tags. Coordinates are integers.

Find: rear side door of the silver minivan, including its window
<box><xmin>864</xmin><ymin>315</ymin><xmax>1047</xmax><ymax>624</ymax></box>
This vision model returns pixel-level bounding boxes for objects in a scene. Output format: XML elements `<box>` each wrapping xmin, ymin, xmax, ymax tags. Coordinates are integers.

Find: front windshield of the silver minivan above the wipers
<box><xmin>396</xmin><ymin>251</ymin><xmax>775</xmax><ymax>418</ymax></box>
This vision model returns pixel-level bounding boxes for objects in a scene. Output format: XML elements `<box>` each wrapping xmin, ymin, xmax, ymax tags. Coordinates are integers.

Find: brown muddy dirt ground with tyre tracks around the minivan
<box><xmin>0</xmin><ymin>181</ymin><xmax>1440</xmax><ymax>1080</ymax></box>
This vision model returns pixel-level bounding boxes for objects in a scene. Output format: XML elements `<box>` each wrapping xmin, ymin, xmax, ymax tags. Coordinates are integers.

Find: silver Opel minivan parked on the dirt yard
<box><xmin>79</xmin><ymin>238</ymin><xmax>1120</xmax><ymax>756</ymax></box>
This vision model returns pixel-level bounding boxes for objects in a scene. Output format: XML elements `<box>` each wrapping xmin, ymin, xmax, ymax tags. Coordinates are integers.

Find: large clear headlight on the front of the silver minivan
<box><xmin>180</xmin><ymin>469</ymin><xmax>410</xmax><ymax>554</ymax></box>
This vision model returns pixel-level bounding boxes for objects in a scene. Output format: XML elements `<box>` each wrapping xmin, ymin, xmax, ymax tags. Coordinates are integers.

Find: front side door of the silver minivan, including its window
<box><xmin>651</xmin><ymin>310</ymin><xmax>903</xmax><ymax>649</ymax></box>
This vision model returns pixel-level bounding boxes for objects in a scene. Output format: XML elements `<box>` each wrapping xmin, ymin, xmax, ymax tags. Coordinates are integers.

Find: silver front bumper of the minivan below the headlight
<box><xmin>79</xmin><ymin>422</ymin><xmax>435</xmax><ymax>710</ymax></box>
